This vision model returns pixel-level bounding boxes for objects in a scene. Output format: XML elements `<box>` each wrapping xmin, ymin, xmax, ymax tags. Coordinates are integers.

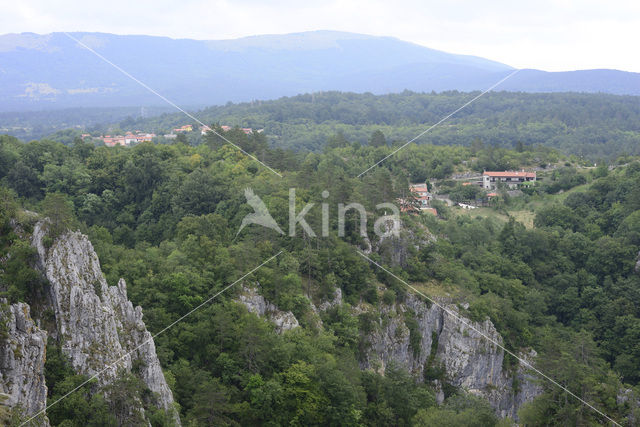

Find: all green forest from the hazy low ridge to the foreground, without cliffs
<box><xmin>0</xmin><ymin>129</ymin><xmax>640</xmax><ymax>426</ymax></box>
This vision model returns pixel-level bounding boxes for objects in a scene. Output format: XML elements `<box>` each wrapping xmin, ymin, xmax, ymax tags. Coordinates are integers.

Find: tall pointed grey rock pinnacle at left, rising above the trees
<box><xmin>32</xmin><ymin>222</ymin><xmax>179</xmax><ymax>424</ymax></box>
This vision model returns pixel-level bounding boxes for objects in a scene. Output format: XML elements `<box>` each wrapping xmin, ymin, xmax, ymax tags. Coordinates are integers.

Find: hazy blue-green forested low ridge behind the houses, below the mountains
<box><xmin>110</xmin><ymin>91</ymin><xmax>640</xmax><ymax>161</ymax></box>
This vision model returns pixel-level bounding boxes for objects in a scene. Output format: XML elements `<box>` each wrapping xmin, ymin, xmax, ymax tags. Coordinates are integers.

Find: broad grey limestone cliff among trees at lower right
<box><xmin>362</xmin><ymin>294</ymin><xmax>542</xmax><ymax>419</ymax></box>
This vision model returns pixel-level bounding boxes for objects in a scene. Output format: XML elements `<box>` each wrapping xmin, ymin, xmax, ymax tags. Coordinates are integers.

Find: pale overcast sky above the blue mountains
<box><xmin>5</xmin><ymin>0</ymin><xmax>640</xmax><ymax>72</ymax></box>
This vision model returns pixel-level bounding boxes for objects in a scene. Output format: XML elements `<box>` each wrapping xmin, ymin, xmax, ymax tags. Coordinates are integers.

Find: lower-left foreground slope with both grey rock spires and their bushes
<box><xmin>0</xmin><ymin>213</ymin><xmax>180</xmax><ymax>427</ymax></box>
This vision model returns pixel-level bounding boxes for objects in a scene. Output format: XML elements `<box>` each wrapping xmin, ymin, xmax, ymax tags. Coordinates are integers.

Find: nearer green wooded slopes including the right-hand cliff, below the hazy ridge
<box><xmin>0</xmin><ymin>131</ymin><xmax>640</xmax><ymax>425</ymax></box>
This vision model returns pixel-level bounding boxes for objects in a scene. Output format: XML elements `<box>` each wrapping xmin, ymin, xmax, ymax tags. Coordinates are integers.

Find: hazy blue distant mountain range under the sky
<box><xmin>0</xmin><ymin>31</ymin><xmax>640</xmax><ymax>111</ymax></box>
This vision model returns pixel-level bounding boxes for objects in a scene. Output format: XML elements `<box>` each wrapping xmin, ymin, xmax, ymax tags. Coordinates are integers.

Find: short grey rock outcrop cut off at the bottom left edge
<box><xmin>0</xmin><ymin>300</ymin><xmax>49</xmax><ymax>426</ymax></box>
